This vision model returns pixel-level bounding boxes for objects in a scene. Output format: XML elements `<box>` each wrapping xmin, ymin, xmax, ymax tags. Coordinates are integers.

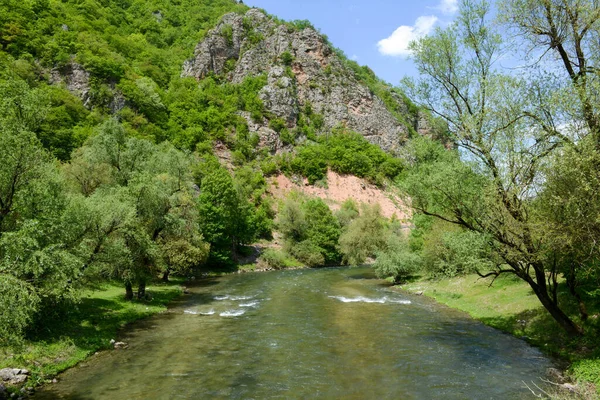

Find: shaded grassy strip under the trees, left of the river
<box><xmin>0</xmin><ymin>281</ymin><xmax>181</xmax><ymax>387</ymax></box>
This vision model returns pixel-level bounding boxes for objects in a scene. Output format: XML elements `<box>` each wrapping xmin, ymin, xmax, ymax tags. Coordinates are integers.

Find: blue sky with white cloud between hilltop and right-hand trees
<box><xmin>244</xmin><ymin>0</ymin><xmax>457</xmax><ymax>85</ymax></box>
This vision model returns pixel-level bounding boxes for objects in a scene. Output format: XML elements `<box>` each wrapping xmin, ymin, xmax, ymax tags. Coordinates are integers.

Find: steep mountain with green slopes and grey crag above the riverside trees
<box><xmin>0</xmin><ymin>0</ymin><xmax>444</xmax><ymax>159</ymax></box>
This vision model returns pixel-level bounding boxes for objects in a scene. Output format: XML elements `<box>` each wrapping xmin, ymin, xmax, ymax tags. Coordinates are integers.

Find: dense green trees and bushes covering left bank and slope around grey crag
<box><xmin>0</xmin><ymin>0</ymin><xmax>412</xmax><ymax>354</ymax></box>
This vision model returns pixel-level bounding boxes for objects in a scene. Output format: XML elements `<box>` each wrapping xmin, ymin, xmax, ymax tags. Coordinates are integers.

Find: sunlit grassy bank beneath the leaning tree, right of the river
<box><xmin>403</xmin><ymin>275</ymin><xmax>600</xmax><ymax>398</ymax></box>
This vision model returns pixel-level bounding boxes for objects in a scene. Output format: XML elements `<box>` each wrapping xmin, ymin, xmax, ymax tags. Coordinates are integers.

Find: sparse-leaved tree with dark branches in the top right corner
<box><xmin>500</xmin><ymin>0</ymin><xmax>600</xmax><ymax>149</ymax></box>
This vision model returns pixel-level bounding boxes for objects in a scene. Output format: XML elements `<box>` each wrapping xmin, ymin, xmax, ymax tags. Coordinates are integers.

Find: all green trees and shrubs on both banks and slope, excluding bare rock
<box><xmin>0</xmin><ymin>0</ymin><xmax>600</xmax><ymax>396</ymax></box>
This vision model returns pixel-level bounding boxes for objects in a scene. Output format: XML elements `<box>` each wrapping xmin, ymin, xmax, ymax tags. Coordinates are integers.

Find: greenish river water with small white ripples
<box><xmin>36</xmin><ymin>268</ymin><xmax>551</xmax><ymax>400</ymax></box>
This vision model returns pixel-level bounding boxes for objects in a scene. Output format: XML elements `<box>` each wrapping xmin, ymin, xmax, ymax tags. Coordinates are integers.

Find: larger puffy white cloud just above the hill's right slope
<box><xmin>377</xmin><ymin>16</ymin><xmax>438</xmax><ymax>56</ymax></box>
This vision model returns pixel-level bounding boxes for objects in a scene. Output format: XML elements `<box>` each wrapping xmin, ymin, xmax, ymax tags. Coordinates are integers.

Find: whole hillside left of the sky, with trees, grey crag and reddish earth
<box><xmin>0</xmin><ymin>0</ymin><xmax>436</xmax><ymax>347</ymax></box>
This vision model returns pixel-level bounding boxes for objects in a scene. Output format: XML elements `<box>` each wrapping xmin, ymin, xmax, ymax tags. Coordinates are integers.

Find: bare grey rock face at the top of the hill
<box><xmin>182</xmin><ymin>9</ymin><xmax>427</xmax><ymax>152</ymax></box>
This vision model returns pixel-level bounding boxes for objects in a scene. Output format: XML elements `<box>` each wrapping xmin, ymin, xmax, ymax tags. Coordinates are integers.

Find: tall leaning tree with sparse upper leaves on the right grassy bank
<box><xmin>405</xmin><ymin>0</ymin><xmax>582</xmax><ymax>335</ymax></box>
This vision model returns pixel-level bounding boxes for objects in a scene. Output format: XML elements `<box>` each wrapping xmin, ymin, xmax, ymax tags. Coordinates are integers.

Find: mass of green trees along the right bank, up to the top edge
<box><xmin>370</xmin><ymin>0</ymin><xmax>600</xmax><ymax>394</ymax></box>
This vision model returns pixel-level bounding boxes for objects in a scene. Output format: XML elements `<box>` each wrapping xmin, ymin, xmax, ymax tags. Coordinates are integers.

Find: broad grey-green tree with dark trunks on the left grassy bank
<box><xmin>66</xmin><ymin>119</ymin><xmax>208</xmax><ymax>298</ymax></box>
